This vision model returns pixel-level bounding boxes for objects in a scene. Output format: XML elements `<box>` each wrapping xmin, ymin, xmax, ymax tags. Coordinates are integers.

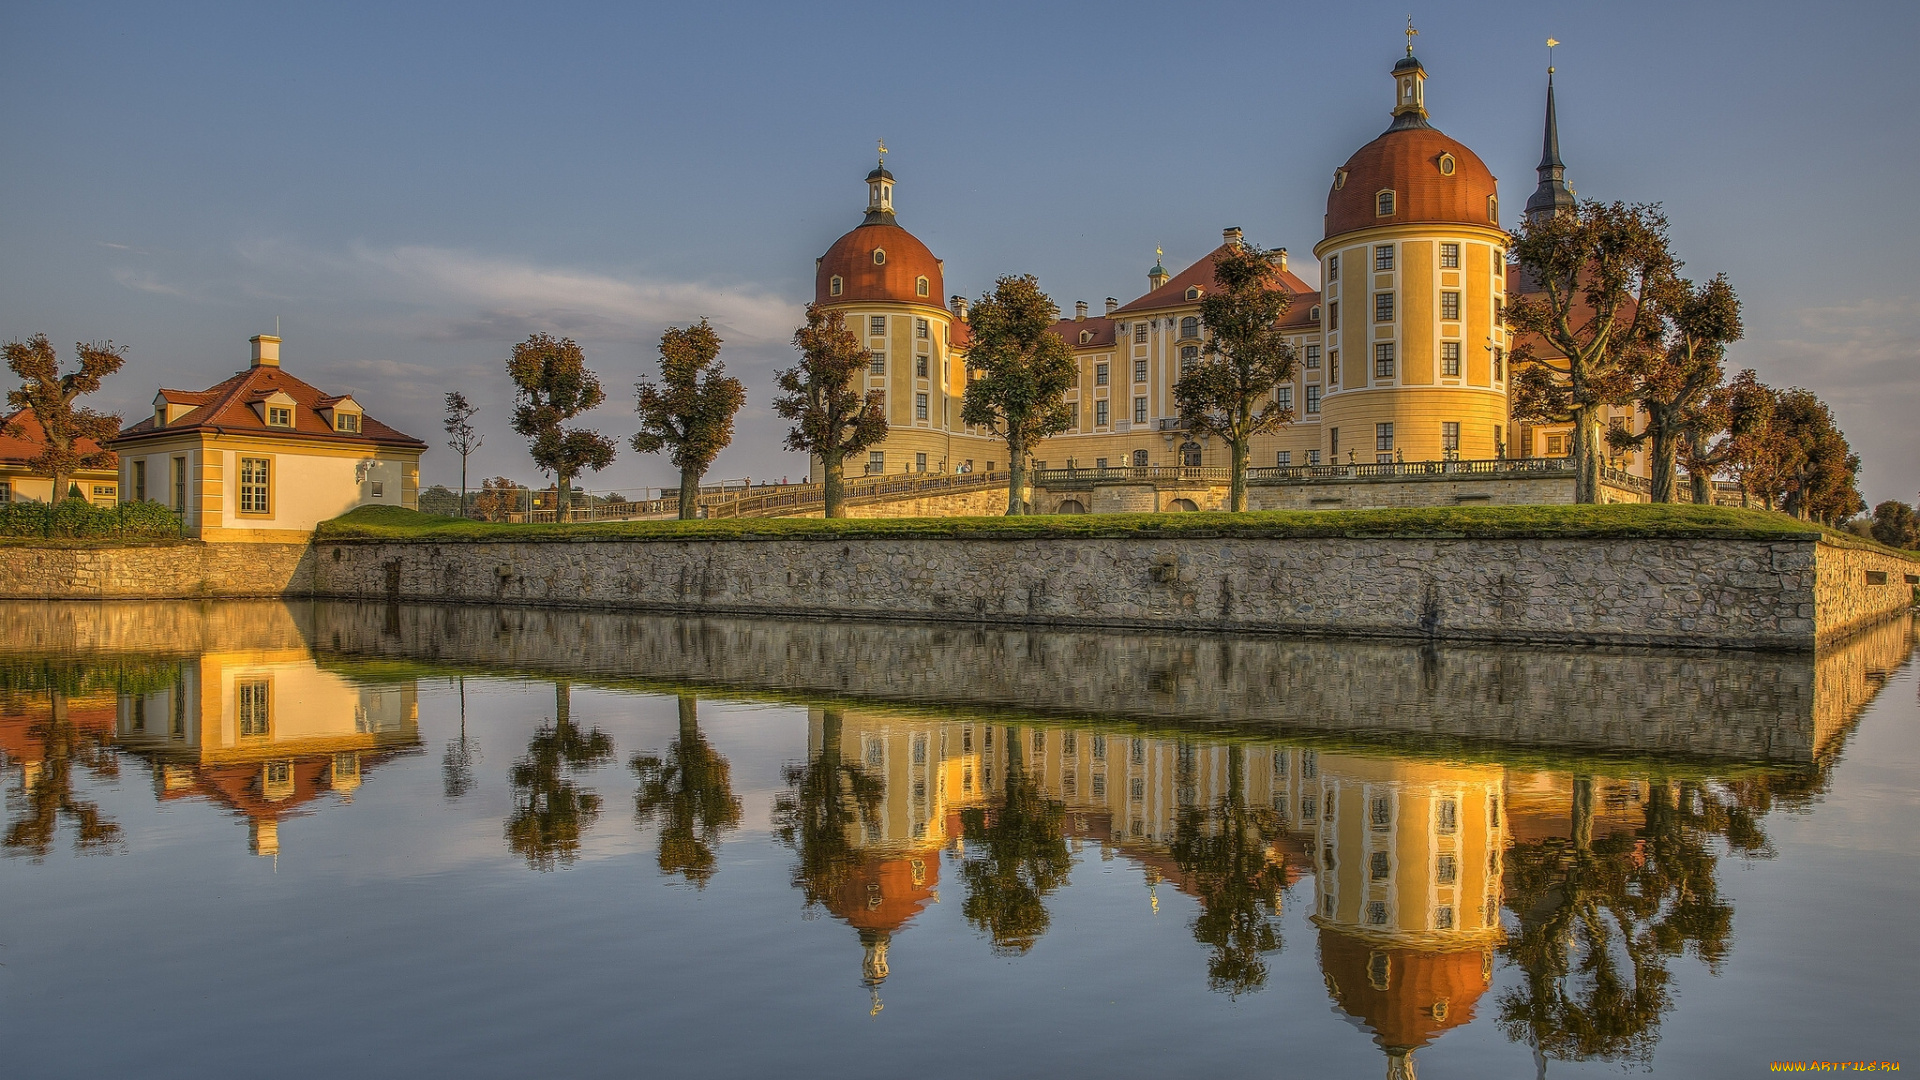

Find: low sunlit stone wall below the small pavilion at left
<box><xmin>0</xmin><ymin>540</ymin><xmax>313</xmax><ymax>600</ymax></box>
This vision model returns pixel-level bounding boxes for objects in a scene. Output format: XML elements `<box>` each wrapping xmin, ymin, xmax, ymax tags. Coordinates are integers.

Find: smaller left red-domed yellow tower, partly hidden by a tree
<box><xmin>814</xmin><ymin>150</ymin><xmax>995</xmax><ymax>479</ymax></box>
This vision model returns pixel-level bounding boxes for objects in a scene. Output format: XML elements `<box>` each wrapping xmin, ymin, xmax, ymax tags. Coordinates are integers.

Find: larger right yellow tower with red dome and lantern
<box><xmin>1313</xmin><ymin>48</ymin><xmax>1507</xmax><ymax>463</ymax></box>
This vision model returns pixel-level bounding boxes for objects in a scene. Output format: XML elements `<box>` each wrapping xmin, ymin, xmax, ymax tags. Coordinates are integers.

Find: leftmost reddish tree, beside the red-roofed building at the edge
<box><xmin>6</xmin><ymin>334</ymin><xmax>127</xmax><ymax>502</ymax></box>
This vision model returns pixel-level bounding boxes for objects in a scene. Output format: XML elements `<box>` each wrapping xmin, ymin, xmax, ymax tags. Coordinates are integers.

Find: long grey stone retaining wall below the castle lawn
<box><xmin>313</xmin><ymin>536</ymin><xmax>1912</xmax><ymax>650</ymax></box>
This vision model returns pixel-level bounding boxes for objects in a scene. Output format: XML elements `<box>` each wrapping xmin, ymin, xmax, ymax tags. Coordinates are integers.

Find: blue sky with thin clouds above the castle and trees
<box><xmin>0</xmin><ymin>0</ymin><xmax>1920</xmax><ymax>502</ymax></box>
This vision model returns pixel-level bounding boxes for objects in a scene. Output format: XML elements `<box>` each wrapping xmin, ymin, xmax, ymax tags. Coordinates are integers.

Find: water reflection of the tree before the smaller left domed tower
<box><xmin>774</xmin><ymin>709</ymin><xmax>887</xmax><ymax>907</ymax></box>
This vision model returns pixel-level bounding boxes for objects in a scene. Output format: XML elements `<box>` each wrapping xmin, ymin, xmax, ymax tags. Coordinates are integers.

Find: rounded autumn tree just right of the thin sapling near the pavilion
<box><xmin>507</xmin><ymin>334</ymin><xmax>614</xmax><ymax>521</ymax></box>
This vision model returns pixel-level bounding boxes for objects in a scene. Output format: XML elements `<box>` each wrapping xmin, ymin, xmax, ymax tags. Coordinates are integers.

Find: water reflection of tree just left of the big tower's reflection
<box><xmin>1173</xmin><ymin>746</ymin><xmax>1286</xmax><ymax>995</ymax></box>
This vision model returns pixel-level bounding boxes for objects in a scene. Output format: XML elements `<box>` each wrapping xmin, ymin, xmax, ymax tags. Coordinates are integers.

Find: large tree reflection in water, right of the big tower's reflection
<box><xmin>1500</xmin><ymin>776</ymin><xmax>1764</xmax><ymax>1072</ymax></box>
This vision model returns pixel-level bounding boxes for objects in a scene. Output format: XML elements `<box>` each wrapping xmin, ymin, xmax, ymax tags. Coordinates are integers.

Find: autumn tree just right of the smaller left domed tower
<box><xmin>960</xmin><ymin>275</ymin><xmax>1079</xmax><ymax>513</ymax></box>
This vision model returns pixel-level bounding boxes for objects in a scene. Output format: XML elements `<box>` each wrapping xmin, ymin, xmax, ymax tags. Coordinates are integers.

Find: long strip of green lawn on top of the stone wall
<box><xmin>317</xmin><ymin>503</ymin><xmax>1904</xmax><ymax>548</ymax></box>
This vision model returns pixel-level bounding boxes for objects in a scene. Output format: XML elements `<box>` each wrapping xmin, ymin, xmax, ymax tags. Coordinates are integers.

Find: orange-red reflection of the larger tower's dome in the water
<box><xmin>1319</xmin><ymin>926</ymin><xmax>1494</xmax><ymax>1055</ymax></box>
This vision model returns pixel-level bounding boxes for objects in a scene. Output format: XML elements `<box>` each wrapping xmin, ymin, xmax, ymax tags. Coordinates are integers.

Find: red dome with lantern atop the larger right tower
<box><xmin>1327</xmin><ymin>56</ymin><xmax>1500</xmax><ymax>236</ymax></box>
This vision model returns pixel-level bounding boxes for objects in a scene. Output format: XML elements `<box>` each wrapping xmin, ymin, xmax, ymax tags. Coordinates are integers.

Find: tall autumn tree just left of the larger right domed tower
<box><xmin>1173</xmin><ymin>242</ymin><xmax>1294</xmax><ymax>511</ymax></box>
